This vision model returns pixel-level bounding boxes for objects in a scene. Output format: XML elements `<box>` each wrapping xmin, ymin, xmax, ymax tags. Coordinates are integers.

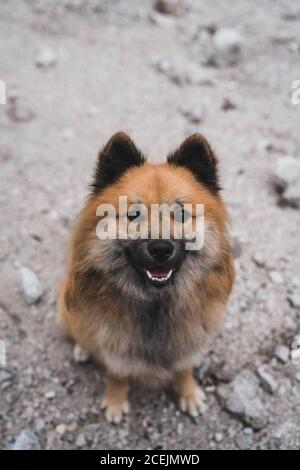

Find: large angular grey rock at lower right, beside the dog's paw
<box><xmin>217</xmin><ymin>369</ymin><xmax>268</xmax><ymax>430</ymax></box>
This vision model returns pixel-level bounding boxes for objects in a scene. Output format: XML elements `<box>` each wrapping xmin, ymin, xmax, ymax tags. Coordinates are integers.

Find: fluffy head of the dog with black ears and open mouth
<box><xmin>74</xmin><ymin>133</ymin><xmax>230</xmax><ymax>297</ymax></box>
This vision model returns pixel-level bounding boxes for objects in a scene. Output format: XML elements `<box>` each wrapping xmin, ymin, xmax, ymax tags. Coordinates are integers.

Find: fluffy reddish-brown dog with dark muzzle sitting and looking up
<box><xmin>58</xmin><ymin>133</ymin><xmax>234</xmax><ymax>422</ymax></box>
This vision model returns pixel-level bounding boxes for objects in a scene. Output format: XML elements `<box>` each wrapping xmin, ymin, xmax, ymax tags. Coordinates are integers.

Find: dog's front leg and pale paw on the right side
<box><xmin>173</xmin><ymin>369</ymin><xmax>207</xmax><ymax>417</ymax></box>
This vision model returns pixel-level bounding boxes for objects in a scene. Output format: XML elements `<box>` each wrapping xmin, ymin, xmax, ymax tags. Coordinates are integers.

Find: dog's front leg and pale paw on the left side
<box><xmin>101</xmin><ymin>372</ymin><xmax>129</xmax><ymax>423</ymax></box>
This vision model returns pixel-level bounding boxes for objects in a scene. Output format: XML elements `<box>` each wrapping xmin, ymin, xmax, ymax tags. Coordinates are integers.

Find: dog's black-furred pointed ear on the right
<box><xmin>168</xmin><ymin>134</ymin><xmax>221</xmax><ymax>193</ymax></box>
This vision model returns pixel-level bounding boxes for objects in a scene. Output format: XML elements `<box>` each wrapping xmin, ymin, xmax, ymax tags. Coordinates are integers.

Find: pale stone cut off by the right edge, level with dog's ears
<box><xmin>273</xmin><ymin>156</ymin><xmax>300</xmax><ymax>209</ymax></box>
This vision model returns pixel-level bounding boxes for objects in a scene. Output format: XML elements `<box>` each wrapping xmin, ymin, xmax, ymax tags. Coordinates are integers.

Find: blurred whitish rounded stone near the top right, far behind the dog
<box><xmin>213</xmin><ymin>28</ymin><xmax>243</xmax><ymax>65</ymax></box>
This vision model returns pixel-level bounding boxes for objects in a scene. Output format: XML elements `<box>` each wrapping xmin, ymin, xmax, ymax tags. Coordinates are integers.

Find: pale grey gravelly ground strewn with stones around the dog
<box><xmin>0</xmin><ymin>0</ymin><xmax>300</xmax><ymax>449</ymax></box>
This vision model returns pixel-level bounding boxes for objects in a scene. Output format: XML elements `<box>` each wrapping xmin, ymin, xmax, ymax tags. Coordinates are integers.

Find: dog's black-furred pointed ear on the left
<box><xmin>91</xmin><ymin>132</ymin><xmax>145</xmax><ymax>195</ymax></box>
